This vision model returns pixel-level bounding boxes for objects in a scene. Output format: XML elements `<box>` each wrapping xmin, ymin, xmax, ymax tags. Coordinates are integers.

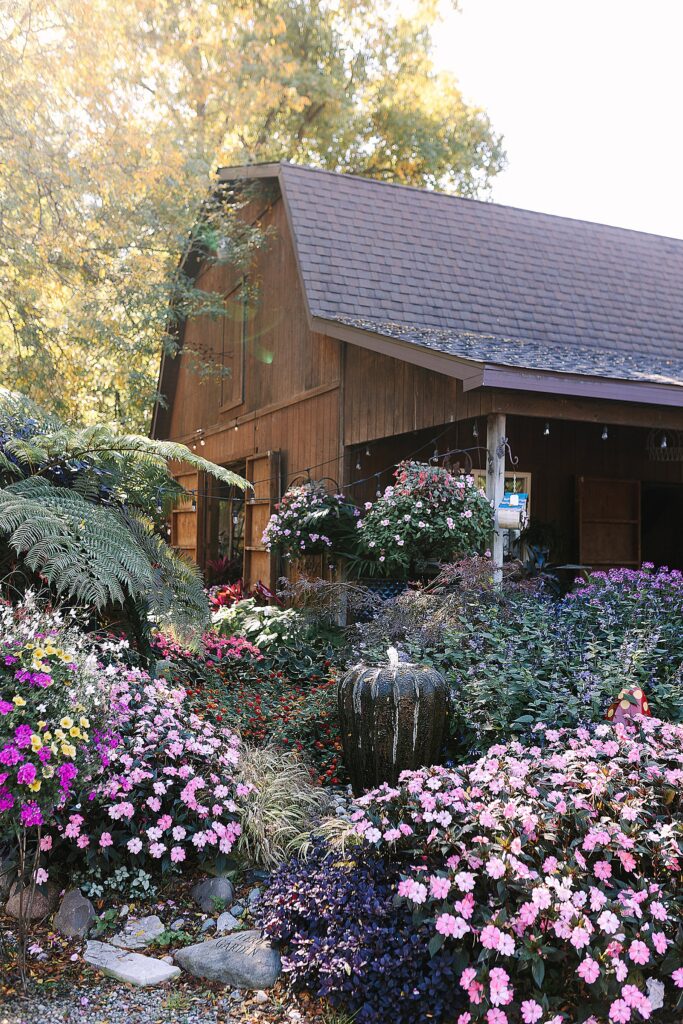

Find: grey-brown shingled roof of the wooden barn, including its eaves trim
<box><xmin>220</xmin><ymin>157</ymin><xmax>683</xmax><ymax>406</ymax></box>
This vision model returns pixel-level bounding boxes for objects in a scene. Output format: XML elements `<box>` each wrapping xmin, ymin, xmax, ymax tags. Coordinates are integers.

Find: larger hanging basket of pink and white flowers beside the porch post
<box><xmin>357</xmin><ymin>462</ymin><xmax>494</xmax><ymax>577</ymax></box>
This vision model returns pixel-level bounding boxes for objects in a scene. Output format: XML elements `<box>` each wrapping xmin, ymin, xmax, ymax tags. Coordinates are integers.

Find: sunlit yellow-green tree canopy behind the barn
<box><xmin>0</xmin><ymin>0</ymin><xmax>504</xmax><ymax>429</ymax></box>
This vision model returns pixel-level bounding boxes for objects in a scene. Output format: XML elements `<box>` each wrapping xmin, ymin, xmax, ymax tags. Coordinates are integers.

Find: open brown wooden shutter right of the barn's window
<box><xmin>244</xmin><ymin>452</ymin><xmax>280</xmax><ymax>590</ymax></box>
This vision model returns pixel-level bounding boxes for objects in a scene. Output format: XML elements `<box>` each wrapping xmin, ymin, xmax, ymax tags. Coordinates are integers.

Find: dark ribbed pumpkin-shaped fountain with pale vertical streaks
<box><xmin>338</xmin><ymin>651</ymin><xmax>446</xmax><ymax>796</ymax></box>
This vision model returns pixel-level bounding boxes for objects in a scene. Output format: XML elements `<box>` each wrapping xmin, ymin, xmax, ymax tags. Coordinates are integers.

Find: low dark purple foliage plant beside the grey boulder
<box><xmin>260</xmin><ymin>843</ymin><xmax>464</xmax><ymax>1024</ymax></box>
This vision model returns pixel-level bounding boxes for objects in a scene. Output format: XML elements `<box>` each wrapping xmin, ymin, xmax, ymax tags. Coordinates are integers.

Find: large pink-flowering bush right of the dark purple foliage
<box><xmin>354</xmin><ymin>719</ymin><xmax>683</xmax><ymax>1024</ymax></box>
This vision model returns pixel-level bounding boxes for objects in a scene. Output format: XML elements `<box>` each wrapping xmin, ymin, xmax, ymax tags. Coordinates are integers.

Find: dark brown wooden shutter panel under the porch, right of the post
<box><xmin>578</xmin><ymin>476</ymin><xmax>640</xmax><ymax>569</ymax></box>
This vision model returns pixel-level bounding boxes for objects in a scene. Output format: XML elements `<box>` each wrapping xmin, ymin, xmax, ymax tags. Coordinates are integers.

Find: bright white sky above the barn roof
<box><xmin>438</xmin><ymin>0</ymin><xmax>683</xmax><ymax>238</ymax></box>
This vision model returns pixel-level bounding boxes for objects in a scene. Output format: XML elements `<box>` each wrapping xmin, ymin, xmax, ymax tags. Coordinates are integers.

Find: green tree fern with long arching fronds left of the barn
<box><xmin>0</xmin><ymin>390</ymin><xmax>248</xmax><ymax>635</ymax></box>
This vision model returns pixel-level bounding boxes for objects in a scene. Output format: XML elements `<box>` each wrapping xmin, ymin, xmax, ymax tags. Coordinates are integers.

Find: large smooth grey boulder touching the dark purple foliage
<box><xmin>174</xmin><ymin>931</ymin><xmax>282</xmax><ymax>989</ymax></box>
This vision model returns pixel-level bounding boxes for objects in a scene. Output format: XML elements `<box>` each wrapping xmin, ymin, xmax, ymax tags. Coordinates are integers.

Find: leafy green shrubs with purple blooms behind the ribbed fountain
<box><xmin>352</xmin><ymin>567</ymin><xmax>683</xmax><ymax>757</ymax></box>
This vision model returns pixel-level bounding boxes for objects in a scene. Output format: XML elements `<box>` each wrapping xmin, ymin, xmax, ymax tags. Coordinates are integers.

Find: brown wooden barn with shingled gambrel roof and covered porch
<box><xmin>153</xmin><ymin>163</ymin><xmax>683</xmax><ymax>584</ymax></box>
